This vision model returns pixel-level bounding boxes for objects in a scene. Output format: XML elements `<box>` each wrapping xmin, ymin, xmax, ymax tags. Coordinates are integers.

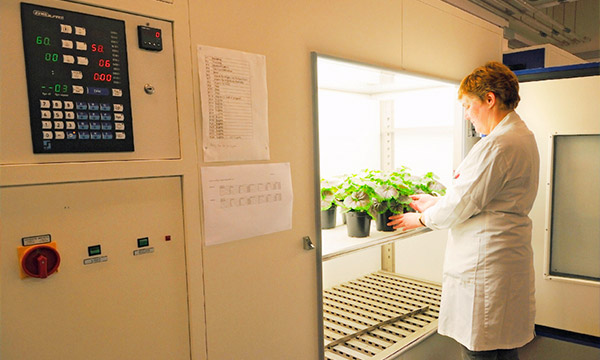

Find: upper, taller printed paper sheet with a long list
<box><xmin>198</xmin><ymin>45</ymin><xmax>269</xmax><ymax>162</ymax></box>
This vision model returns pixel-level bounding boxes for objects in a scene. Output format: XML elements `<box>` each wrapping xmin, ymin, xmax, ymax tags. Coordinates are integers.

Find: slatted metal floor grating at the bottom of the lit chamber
<box><xmin>323</xmin><ymin>271</ymin><xmax>442</xmax><ymax>360</ymax></box>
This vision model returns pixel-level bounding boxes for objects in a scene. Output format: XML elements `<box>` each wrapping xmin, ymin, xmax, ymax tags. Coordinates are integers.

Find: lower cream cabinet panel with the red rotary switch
<box><xmin>0</xmin><ymin>177</ymin><xmax>190</xmax><ymax>360</ymax></box>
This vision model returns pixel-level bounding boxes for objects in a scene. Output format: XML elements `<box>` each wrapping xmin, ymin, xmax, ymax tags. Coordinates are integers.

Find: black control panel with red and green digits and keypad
<box><xmin>21</xmin><ymin>3</ymin><xmax>134</xmax><ymax>153</ymax></box>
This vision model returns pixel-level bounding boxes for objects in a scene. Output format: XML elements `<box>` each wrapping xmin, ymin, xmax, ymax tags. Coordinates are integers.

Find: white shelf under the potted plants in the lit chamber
<box><xmin>321</xmin><ymin>221</ymin><xmax>431</xmax><ymax>261</ymax></box>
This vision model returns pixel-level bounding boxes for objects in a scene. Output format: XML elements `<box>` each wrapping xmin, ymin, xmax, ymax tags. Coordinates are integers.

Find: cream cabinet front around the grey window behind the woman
<box><xmin>516</xmin><ymin>76</ymin><xmax>600</xmax><ymax>336</ymax></box>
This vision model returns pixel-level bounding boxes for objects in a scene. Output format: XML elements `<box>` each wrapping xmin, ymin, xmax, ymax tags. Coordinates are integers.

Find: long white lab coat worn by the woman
<box><xmin>423</xmin><ymin>111</ymin><xmax>539</xmax><ymax>351</ymax></box>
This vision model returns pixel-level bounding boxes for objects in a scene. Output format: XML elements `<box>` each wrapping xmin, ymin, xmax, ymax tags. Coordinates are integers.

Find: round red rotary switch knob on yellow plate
<box><xmin>21</xmin><ymin>244</ymin><xmax>60</xmax><ymax>279</ymax></box>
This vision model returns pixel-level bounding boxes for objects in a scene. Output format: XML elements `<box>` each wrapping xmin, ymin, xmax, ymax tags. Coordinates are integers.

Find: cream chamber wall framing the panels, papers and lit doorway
<box><xmin>0</xmin><ymin>0</ymin><xmax>502</xmax><ymax>359</ymax></box>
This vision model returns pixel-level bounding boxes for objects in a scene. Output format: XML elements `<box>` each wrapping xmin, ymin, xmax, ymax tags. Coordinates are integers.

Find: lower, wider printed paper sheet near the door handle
<box><xmin>201</xmin><ymin>163</ymin><xmax>293</xmax><ymax>246</ymax></box>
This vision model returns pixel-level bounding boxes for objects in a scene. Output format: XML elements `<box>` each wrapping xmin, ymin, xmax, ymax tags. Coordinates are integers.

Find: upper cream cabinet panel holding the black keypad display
<box><xmin>0</xmin><ymin>0</ymin><xmax>181</xmax><ymax>164</ymax></box>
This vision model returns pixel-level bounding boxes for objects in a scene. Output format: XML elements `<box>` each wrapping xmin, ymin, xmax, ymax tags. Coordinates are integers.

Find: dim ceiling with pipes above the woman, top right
<box><xmin>444</xmin><ymin>0</ymin><xmax>600</xmax><ymax>62</ymax></box>
